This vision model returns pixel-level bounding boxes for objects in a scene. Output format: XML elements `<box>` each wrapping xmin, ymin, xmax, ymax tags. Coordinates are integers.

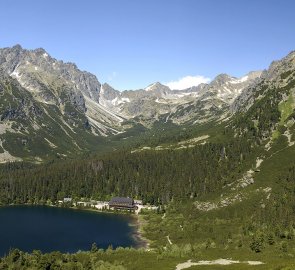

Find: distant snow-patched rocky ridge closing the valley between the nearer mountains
<box><xmin>100</xmin><ymin>72</ymin><xmax>261</xmax><ymax>126</ymax></box>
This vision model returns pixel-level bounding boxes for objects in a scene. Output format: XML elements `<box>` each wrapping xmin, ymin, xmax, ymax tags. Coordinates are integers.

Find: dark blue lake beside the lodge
<box><xmin>0</xmin><ymin>206</ymin><xmax>138</xmax><ymax>256</ymax></box>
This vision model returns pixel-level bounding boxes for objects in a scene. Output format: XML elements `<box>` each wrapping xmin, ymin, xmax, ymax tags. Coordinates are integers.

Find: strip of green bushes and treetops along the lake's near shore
<box><xmin>0</xmin><ymin>243</ymin><xmax>197</xmax><ymax>270</ymax></box>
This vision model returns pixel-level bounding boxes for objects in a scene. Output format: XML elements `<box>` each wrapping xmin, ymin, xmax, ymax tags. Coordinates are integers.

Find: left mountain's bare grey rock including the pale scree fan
<box><xmin>0</xmin><ymin>45</ymin><xmax>122</xmax><ymax>138</ymax></box>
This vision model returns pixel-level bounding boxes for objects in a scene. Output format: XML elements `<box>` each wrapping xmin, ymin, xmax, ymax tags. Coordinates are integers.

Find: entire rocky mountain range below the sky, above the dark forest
<box><xmin>0</xmin><ymin>45</ymin><xmax>295</xmax><ymax>162</ymax></box>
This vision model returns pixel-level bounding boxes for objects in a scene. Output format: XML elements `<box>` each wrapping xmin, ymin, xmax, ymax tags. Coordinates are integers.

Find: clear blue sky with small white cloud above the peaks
<box><xmin>0</xmin><ymin>0</ymin><xmax>295</xmax><ymax>90</ymax></box>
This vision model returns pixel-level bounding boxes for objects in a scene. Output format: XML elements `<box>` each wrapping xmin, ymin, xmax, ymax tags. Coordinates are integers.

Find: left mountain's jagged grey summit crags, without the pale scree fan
<box><xmin>0</xmin><ymin>45</ymin><xmax>100</xmax><ymax>111</ymax></box>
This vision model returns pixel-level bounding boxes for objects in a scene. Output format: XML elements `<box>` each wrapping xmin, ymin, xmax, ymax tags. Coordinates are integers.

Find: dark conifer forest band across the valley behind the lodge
<box><xmin>0</xmin><ymin>135</ymin><xmax>251</xmax><ymax>204</ymax></box>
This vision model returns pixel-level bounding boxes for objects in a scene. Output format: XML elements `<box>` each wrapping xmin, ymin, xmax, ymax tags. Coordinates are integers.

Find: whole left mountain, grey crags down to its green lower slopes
<box><xmin>0</xmin><ymin>45</ymin><xmax>127</xmax><ymax>162</ymax></box>
